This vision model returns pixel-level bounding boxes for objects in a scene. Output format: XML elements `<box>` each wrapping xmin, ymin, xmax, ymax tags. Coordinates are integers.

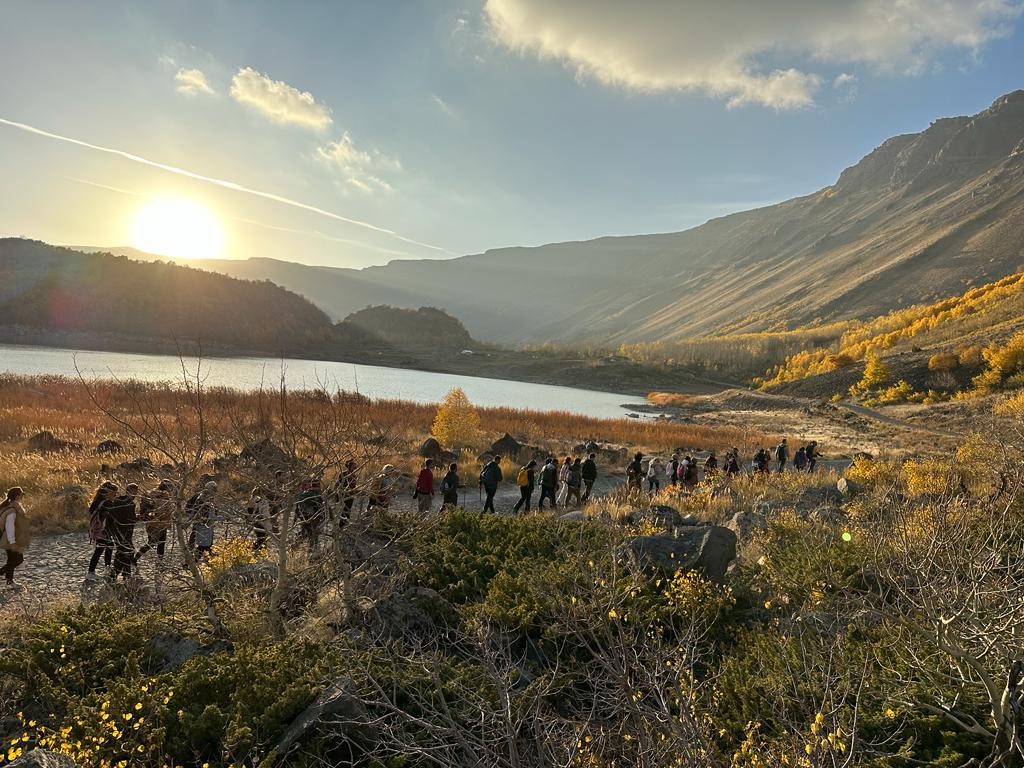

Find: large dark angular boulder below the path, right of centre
<box><xmin>629</xmin><ymin>525</ymin><xmax>736</xmax><ymax>584</ymax></box>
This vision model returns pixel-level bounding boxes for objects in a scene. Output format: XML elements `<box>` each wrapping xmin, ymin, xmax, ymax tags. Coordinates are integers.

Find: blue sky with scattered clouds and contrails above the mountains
<box><xmin>0</xmin><ymin>0</ymin><xmax>1024</xmax><ymax>268</ymax></box>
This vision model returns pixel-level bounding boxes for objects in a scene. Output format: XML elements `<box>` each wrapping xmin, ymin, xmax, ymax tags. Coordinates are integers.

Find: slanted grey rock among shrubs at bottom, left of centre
<box><xmin>260</xmin><ymin>680</ymin><xmax>377</xmax><ymax>766</ymax></box>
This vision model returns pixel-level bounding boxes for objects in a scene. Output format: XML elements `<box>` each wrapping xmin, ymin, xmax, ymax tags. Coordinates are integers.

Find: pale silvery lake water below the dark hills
<box><xmin>0</xmin><ymin>344</ymin><xmax>643</xmax><ymax>419</ymax></box>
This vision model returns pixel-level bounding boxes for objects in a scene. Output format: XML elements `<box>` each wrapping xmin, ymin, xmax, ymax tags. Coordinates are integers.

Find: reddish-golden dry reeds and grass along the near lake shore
<box><xmin>0</xmin><ymin>375</ymin><xmax>768</xmax><ymax>530</ymax></box>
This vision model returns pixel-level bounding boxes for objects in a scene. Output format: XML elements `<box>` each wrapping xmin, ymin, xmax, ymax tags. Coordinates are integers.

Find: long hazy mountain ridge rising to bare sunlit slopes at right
<box><xmin>130</xmin><ymin>91</ymin><xmax>1024</xmax><ymax>343</ymax></box>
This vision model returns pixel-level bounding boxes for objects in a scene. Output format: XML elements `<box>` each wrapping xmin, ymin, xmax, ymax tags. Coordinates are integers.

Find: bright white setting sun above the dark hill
<box><xmin>131</xmin><ymin>198</ymin><xmax>224</xmax><ymax>259</ymax></box>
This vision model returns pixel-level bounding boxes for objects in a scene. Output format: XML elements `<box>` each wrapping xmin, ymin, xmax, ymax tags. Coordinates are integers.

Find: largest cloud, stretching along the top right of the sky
<box><xmin>484</xmin><ymin>0</ymin><xmax>1022</xmax><ymax>110</ymax></box>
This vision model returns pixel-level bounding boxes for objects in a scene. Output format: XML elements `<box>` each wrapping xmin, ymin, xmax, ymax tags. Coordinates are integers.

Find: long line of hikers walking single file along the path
<box><xmin>0</xmin><ymin>438</ymin><xmax>819</xmax><ymax>587</ymax></box>
